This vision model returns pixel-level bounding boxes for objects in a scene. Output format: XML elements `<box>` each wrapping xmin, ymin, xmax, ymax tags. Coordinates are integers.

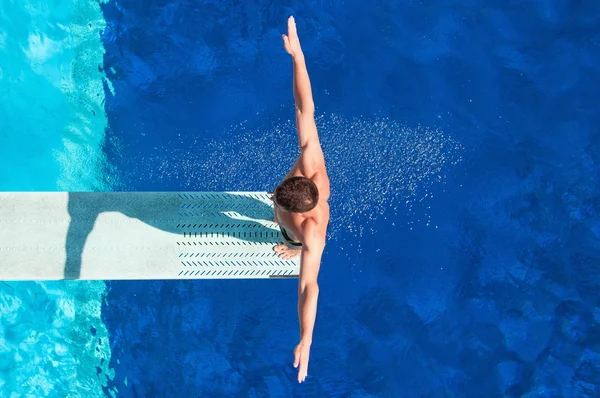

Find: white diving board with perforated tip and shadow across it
<box><xmin>0</xmin><ymin>192</ymin><xmax>300</xmax><ymax>280</ymax></box>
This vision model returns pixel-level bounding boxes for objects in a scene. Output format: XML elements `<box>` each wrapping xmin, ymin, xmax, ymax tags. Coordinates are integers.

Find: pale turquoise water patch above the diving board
<box><xmin>0</xmin><ymin>1</ymin><xmax>109</xmax><ymax>191</ymax></box>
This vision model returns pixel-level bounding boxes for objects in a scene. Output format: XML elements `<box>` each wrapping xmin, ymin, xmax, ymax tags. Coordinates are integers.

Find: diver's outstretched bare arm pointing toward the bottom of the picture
<box><xmin>294</xmin><ymin>220</ymin><xmax>325</xmax><ymax>383</ymax></box>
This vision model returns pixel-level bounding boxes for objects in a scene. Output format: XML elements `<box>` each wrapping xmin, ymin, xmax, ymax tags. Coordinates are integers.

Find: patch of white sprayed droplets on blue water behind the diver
<box><xmin>146</xmin><ymin>114</ymin><xmax>463</xmax><ymax>241</ymax></box>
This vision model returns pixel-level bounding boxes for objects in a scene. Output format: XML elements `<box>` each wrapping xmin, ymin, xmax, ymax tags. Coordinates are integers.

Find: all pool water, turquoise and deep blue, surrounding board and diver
<box><xmin>0</xmin><ymin>0</ymin><xmax>600</xmax><ymax>398</ymax></box>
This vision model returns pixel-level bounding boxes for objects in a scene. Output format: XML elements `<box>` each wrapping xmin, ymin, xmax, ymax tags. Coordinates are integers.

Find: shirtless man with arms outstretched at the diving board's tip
<box><xmin>272</xmin><ymin>17</ymin><xmax>330</xmax><ymax>383</ymax></box>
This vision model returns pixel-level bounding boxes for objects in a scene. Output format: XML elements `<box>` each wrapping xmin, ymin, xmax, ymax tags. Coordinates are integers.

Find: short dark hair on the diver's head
<box><xmin>275</xmin><ymin>177</ymin><xmax>319</xmax><ymax>213</ymax></box>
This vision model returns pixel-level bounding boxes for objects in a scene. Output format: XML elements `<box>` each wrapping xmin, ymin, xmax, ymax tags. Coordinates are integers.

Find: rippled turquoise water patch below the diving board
<box><xmin>0</xmin><ymin>281</ymin><xmax>114</xmax><ymax>397</ymax></box>
